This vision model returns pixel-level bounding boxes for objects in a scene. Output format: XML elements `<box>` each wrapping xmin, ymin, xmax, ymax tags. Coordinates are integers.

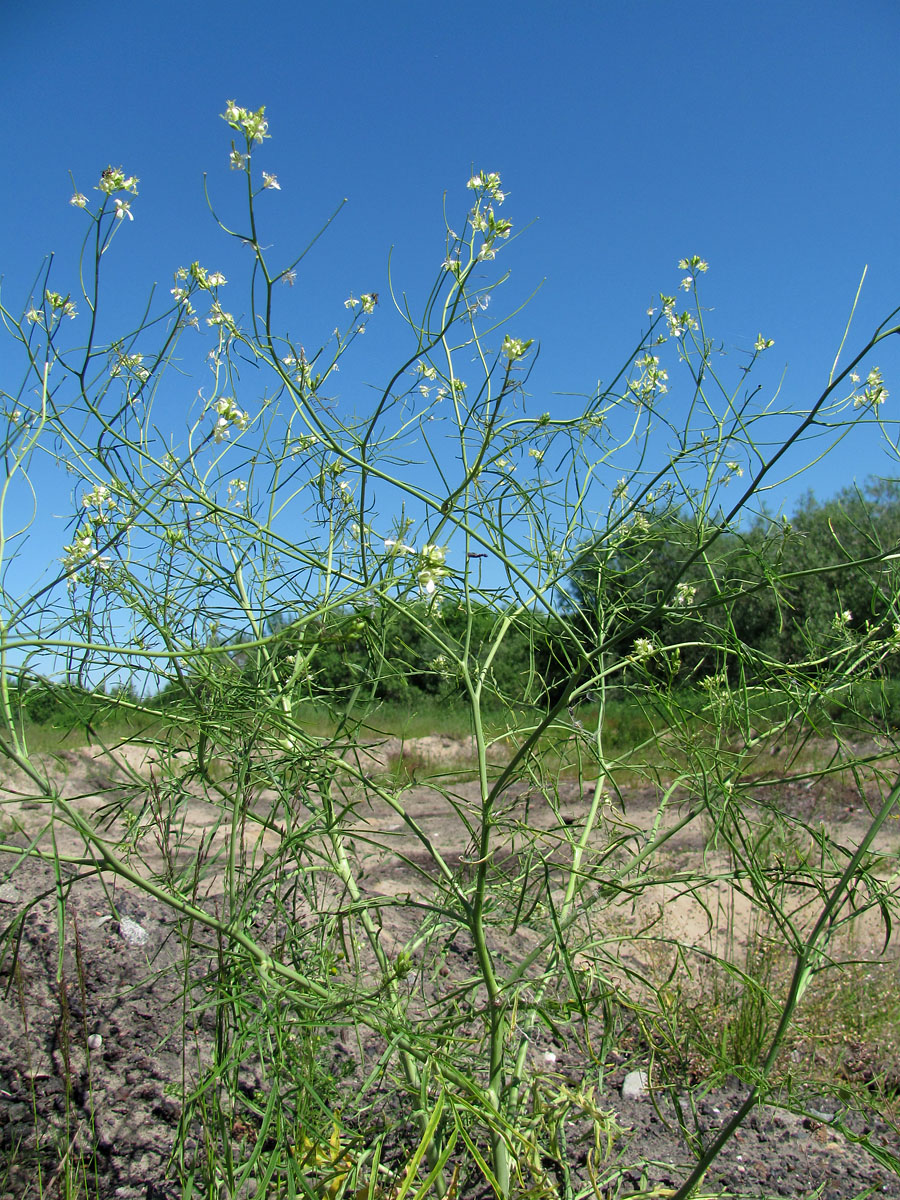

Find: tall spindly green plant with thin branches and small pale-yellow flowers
<box><xmin>0</xmin><ymin>101</ymin><xmax>900</xmax><ymax>1200</ymax></box>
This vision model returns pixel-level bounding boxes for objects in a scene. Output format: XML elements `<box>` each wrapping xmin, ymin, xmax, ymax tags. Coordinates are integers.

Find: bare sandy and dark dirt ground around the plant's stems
<box><xmin>0</xmin><ymin>737</ymin><xmax>900</xmax><ymax>1200</ymax></box>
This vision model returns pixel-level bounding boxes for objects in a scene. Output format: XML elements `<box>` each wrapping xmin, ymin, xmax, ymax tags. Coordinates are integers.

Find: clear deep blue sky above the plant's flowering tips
<box><xmin>0</xmin><ymin>0</ymin><xmax>900</xmax><ymax>609</ymax></box>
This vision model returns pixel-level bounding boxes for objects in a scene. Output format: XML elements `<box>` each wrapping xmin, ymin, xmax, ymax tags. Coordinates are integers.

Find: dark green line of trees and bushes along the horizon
<box><xmin>12</xmin><ymin>480</ymin><xmax>900</xmax><ymax>724</ymax></box>
